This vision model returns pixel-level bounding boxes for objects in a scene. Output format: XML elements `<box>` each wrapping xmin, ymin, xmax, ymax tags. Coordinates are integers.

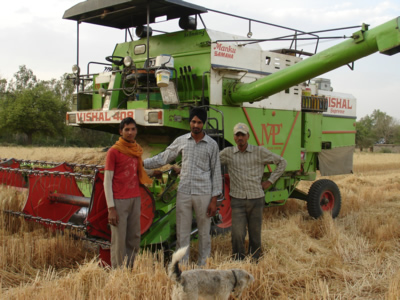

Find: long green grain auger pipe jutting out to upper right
<box><xmin>226</xmin><ymin>17</ymin><xmax>400</xmax><ymax>105</ymax></box>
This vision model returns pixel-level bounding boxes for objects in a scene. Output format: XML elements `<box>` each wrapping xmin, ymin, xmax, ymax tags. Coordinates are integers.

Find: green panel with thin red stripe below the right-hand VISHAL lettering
<box><xmin>322</xmin><ymin>116</ymin><xmax>356</xmax><ymax>148</ymax></box>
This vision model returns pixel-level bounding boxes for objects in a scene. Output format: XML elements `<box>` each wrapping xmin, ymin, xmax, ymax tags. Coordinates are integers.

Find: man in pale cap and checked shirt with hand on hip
<box><xmin>220</xmin><ymin>123</ymin><xmax>286</xmax><ymax>260</ymax></box>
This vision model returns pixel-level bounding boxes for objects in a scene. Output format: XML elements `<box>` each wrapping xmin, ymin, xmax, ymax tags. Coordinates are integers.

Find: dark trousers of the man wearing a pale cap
<box><xmin>231</xmin><ymin>197</ymin><xmax>265</xmax><ymax>259</ymax></box>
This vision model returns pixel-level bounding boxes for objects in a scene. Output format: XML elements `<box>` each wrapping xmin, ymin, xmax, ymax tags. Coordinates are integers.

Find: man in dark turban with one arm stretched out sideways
<box><xmin>144</xmin><ymin>108</ymin><xmax>222</xmax><ymax>266</ymax></box>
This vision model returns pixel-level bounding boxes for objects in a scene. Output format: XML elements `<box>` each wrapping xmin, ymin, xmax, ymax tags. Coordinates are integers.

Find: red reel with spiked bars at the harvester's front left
<box><xmin>0</xmin><ymin>158</ymin><xmax>155</xmax><ymax>265</ymax></box>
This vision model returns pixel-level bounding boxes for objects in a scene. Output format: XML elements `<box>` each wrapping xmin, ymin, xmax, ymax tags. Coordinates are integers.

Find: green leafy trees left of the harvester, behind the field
<box><xmin>0</xmin><ymin>65</ymin><xmax>117</xmax><ymax>147</ymax></box>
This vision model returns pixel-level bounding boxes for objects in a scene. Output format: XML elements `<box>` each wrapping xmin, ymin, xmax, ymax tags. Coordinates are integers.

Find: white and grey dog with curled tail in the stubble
<box><xmin>168</xmin><ymin>247</ymin><xmax>254</xmax><ymax>300</ymax></box>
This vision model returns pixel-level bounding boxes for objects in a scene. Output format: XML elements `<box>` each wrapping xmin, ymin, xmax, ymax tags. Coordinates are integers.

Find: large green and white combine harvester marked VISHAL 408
<box><xmin>0</xmin><ymin>0</ymin><xmax>400</xmax><ymax>268</ymax></box>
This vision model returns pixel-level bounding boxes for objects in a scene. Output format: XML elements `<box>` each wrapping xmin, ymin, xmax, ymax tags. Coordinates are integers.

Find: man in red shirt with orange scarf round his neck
<box><xmin>104</xmin><ymin>118</ymin><xmax>152</xmax><ymax>268</ymax></box>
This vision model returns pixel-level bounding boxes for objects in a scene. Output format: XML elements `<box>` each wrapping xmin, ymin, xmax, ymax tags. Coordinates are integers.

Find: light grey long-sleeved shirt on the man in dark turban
<box><xmin>144</xmin><ymin>133</ymin><xmax>222</xmax><ymax>197</ymax></box>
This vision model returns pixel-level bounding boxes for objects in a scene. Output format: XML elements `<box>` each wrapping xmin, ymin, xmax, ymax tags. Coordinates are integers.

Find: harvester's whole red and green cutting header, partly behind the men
<box><xmin>0</xmin><ymin>158</ymin><xmax>231</xmax><ymax>265</ymax></box>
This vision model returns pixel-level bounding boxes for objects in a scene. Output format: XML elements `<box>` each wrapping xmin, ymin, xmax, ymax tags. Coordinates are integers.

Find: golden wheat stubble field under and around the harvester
<box><xmin>0</xmin><ymin>147</ymin><xmax>400</xmax><ymax>300</ymax></box>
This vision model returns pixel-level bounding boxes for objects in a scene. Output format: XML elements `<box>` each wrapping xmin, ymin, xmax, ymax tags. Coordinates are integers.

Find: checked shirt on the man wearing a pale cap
<box><xmin>220</xmin><ymin>145</ymin><xmax>286</xmax><ymax>199</ymax></box>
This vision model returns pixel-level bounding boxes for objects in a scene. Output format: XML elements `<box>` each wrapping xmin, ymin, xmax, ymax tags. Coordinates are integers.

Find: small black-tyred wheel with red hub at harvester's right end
<box><xmin>307</xmin><ymin>179</ymin><xmax>342</xmax><ymax>219</ymax></box>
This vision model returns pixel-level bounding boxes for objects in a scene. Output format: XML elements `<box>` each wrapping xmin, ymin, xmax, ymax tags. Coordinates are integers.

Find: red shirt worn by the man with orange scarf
<box><xmin>106</xmin><ymin>148</ymin><xmax>140</xmax><ymax>199</ymax></box>
